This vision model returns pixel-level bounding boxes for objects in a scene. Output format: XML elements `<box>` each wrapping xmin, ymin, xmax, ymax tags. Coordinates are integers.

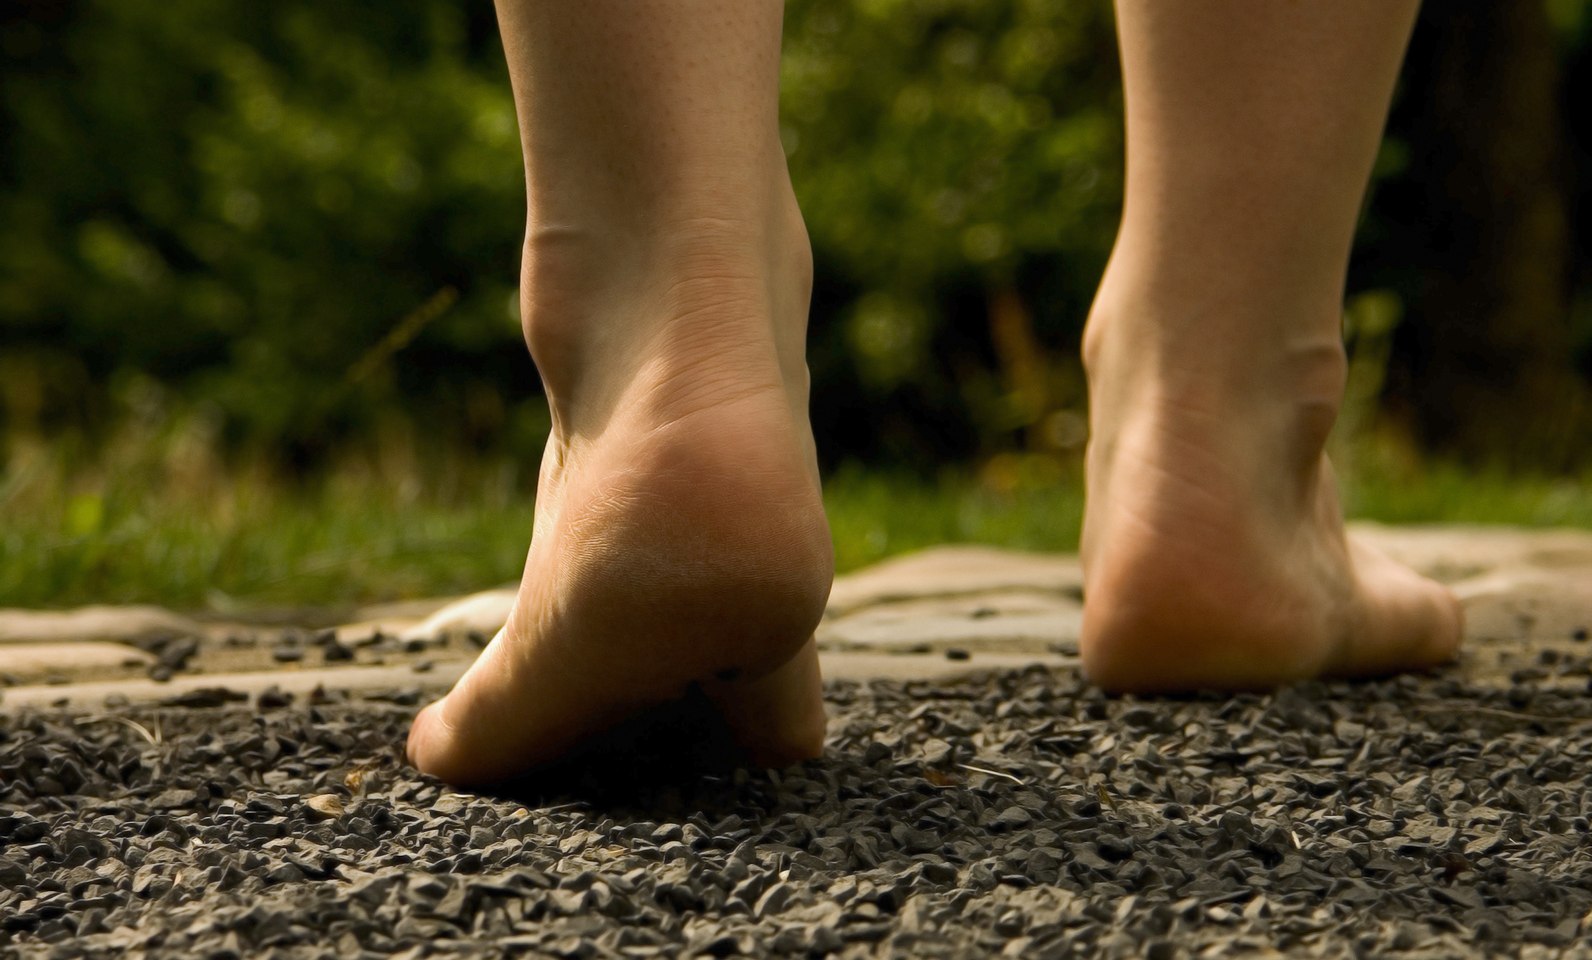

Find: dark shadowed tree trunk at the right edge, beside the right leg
<box><xmin>1377</xmin><ymin>0</ymin><xmax>1592</xmax><ymax>468</ymax></box>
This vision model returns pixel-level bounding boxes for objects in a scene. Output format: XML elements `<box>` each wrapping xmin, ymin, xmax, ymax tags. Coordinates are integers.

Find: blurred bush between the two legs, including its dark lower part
<box><xmin>783</xmin><ymin>0</ymin><xmax>1122</xmax><ymax>464</ymax></box>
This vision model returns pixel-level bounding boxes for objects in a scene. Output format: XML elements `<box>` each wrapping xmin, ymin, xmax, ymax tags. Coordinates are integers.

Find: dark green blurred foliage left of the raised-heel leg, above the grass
<box><xmin>0</xmin><ymin>0</ymin><xmax>535</xmax><ymax>459</ymax></box>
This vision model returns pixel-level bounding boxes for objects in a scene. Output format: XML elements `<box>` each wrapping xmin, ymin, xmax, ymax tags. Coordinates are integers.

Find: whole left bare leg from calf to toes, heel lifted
<box><xmin>409</xmin><ymin>0</ymin><xmax>833</xmax><ymax>782</ymax></box>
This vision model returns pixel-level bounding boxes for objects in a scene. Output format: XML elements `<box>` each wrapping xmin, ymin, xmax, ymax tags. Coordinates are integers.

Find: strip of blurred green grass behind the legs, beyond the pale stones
<box><xmin>0</xmin><ymin>436</ymin><xmax>1592</xmax><ymax>613</ymax></box>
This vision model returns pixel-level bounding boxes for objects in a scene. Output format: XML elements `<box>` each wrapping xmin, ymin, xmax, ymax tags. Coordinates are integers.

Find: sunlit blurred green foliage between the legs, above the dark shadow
<box><xmin>782</xmin><ymin>0</ymin><xmax>1122</xmax><ymax>292</ymax></box>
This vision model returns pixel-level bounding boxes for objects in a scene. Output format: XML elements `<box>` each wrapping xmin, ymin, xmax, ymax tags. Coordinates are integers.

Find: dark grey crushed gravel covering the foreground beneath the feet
<box><xmin>0</xmin><ymin>656</ymin><xmax>1592</xmax><ymax>960</ymax></box>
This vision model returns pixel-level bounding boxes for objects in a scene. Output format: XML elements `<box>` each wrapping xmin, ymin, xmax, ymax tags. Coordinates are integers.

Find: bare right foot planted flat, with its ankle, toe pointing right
<box><xmin>1081</xmin><ymin>289</ymin><xmax>1461</xmax><ymax>693</ymax></box>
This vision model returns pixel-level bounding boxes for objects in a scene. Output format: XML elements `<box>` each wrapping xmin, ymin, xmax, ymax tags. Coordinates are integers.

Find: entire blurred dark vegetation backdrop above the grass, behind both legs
<box><xmin>0</xmin><ymin>0</ymin><xmax>1592</xmax><ymax>476</ymax></box>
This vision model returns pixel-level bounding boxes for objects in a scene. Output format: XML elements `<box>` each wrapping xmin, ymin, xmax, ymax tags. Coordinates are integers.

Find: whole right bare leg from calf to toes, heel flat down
<box><xmin>1083</xmin><ymin>0</ymin><xmax>1458</xmax><ymax>689</ymax></box>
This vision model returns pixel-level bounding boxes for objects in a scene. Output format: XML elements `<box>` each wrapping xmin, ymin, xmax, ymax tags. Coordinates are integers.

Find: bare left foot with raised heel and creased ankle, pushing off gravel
<box><xmin>409</xmin><ymin>199</ymin><xmax>833</xmax><ymax>783</ymax></box>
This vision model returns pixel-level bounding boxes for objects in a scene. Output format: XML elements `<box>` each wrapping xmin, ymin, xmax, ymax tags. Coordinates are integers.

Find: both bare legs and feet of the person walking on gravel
<box><xmin>409</xmin><ymin>0</ymin><xmax>1460</xmax><ymax>783</ymax></box>
